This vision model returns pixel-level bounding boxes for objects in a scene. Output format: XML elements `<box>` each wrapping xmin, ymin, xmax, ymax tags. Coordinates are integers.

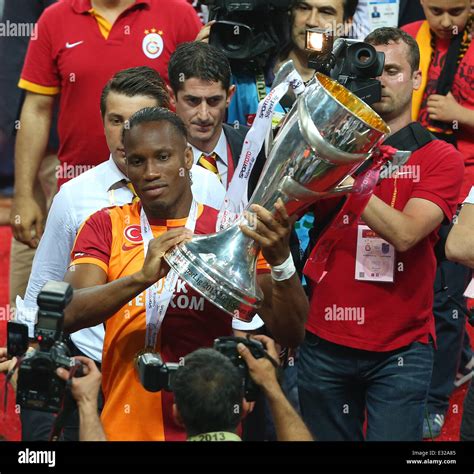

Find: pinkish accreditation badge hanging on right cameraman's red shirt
<box><xmin>355</xmin><ymin>224</ymin><xmax>395</xmax><ymax>282</ymax></box>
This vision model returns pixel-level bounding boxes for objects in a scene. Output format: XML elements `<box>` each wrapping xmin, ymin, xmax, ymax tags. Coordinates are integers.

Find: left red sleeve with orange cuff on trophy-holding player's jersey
<box><xmin>70</xmin><ymin>209</ymin><xmax>112</xmax><ymax>273</ymax></box>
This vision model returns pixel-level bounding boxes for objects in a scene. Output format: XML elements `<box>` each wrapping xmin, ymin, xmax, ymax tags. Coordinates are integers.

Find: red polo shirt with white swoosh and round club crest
<box><xmin>19</xmin><ymin>0</ymin><xmax>202</xmax><ymax>186</ymax></box>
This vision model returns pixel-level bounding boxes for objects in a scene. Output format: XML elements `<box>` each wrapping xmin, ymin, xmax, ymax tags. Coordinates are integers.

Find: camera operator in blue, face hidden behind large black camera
<box><xmin>196</xmin><ymin>0</ymin><xmax>291</xmax><ymax>126</ymax></box>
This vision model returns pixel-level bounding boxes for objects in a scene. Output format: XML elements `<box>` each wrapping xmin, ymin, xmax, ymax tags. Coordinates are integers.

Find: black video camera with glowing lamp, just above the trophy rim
<box><xmin>306</xmin><ymin>28</ymin><xmax>385</xmax><ymax>105</ymax></box>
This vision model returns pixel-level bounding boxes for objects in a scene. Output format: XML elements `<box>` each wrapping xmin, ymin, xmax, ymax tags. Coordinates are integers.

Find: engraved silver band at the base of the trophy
<box><xmin>164</xmin><ymin>244</ymin><xmax>262</xmax><ymax>322</ymax></box>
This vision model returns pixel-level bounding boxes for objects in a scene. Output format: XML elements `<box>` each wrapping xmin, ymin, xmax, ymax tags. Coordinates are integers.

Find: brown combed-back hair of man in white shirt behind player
<box><xmin>100</xmin><ymin>66</ymin><xmax>170</xmax><ymax>117</ymax></box>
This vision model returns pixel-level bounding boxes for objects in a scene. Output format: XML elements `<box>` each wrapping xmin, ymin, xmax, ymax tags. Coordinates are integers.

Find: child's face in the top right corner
<box><xmin>421</xmin><ymin>0</ymin><xmax>471</xmax><ymax>39</ymax></box>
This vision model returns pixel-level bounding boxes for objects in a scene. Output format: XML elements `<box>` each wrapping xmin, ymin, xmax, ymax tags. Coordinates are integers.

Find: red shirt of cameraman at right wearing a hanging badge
<box><xmin>306</xmin><ymin>140</ymin><xmax>463</xmax><ymax>352</ymax></box>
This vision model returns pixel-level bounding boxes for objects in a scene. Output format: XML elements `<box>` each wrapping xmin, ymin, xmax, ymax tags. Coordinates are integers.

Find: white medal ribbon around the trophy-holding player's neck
<box><xmin>140</xmin><ymin>199</ymin><xmax>199</xmax><ymax>350</ymax></box>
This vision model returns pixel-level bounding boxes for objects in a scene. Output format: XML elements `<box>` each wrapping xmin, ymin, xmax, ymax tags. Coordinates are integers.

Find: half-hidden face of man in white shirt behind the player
<box><xmin>103</xmin><ymin>92</ymin><xmax>161</xmax><ymax>173</ymax></box>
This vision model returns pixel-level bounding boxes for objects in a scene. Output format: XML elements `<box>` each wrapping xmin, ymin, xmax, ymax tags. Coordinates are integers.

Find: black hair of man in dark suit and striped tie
<box><xmin>168</xmin><ymin>41</ymin><xmax>231</xmax><ymax>95</ymax></box>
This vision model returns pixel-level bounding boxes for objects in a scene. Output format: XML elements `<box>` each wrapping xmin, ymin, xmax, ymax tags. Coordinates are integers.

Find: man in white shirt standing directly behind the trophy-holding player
<box><xmin>12</xmin><ymin>66</ymin><xmax>225</xmax><ymax>440</ymax></box>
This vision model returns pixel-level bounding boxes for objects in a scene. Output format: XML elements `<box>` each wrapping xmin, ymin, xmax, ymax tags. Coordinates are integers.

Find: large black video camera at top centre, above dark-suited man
<box><xmin>204</xmin><ymin>0</ymin><xmax>291</xmax><ymax>72</ymax></box>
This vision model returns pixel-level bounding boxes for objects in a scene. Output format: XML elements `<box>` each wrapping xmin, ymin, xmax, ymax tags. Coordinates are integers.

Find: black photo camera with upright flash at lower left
<box><xmin>7</xmin><ymin>281</ymin><xmax>82</xmax><ymax>413</ymax></box>
